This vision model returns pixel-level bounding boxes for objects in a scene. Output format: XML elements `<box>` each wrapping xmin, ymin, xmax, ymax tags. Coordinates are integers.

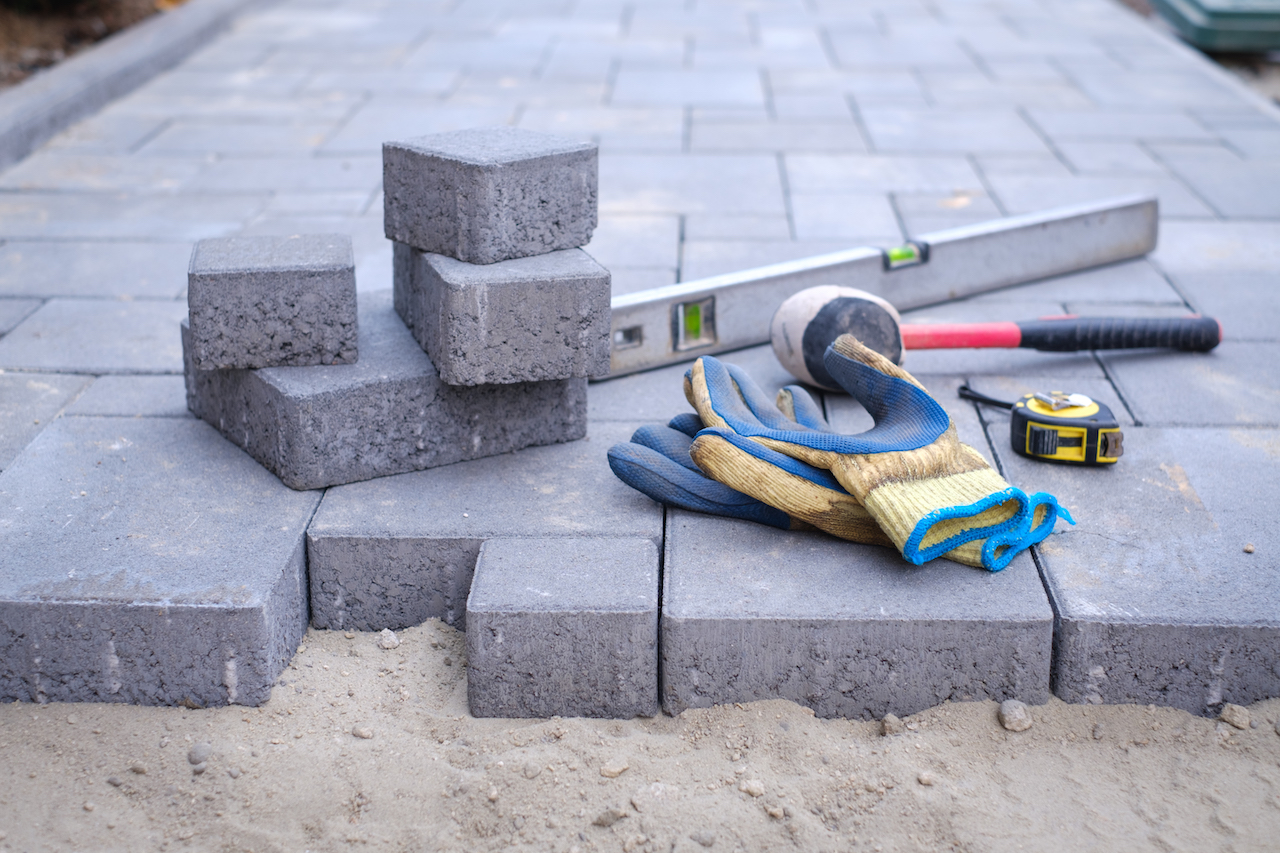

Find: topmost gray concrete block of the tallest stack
<box><xmin>383</xmin><ymin>127</ymin><xmax>598</xmax><ymax>264</ymax></box>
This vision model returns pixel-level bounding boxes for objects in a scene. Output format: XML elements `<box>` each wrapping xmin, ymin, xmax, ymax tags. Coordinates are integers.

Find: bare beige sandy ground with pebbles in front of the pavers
<box><xmin>0</xmin><ymin>621</ymin><xmax>1280</xmax><ymax>853</ymax></box>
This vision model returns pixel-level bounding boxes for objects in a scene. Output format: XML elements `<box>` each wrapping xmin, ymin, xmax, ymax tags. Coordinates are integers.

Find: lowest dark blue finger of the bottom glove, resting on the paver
<box><xmin>608</xmin><ymin>443</ymin><xmax>792</xmax><ymax>530</ymax></box>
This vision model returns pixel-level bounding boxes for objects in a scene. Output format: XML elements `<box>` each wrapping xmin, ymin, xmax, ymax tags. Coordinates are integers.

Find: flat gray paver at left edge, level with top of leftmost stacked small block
<box><xmin>0</xmin><ymin>241</ymin><xmax>191</xmax><ymax>300</ymax></box>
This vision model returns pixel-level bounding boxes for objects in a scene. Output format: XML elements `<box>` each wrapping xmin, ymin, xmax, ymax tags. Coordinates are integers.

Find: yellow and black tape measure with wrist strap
<box><xmin>959</xmin><ymin>384</ymin><xmax>1124</xmax><ymax>465</ymax></box>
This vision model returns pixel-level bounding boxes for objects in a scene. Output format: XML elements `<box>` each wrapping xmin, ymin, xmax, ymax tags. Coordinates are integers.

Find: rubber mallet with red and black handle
<box><xmin>769</xmin><ymin>284</ymin><xmax>1222</xmax><ymax>391</ymax></box>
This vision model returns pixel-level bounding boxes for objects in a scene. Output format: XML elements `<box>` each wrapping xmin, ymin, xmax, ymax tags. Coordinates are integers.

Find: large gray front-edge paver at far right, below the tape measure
<box><xmin>984</xmin><ymin>412</ymin><xmax>1280</xmax><ymax>716</ymax></box>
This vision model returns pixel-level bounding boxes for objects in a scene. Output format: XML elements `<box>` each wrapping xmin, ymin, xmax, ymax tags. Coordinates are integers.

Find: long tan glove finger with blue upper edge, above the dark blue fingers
<box><xmin>690</xmin><ymin>428</ymin><xmax>892</xmax><ymax>546</ymax></box>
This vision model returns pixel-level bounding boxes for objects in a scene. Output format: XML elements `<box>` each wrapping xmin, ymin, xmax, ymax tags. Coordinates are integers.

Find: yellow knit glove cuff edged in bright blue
<box><xmin>863</xmin><ymin>467</ymin><xmax>1030</xmax><ymax>563</ymax></box>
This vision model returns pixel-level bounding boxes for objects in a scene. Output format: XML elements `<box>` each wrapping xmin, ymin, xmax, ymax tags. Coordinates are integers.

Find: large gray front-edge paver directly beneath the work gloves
<box><xmin>659</xmin><ymin>510</ymin><xmax>1052</xmax><ymax>720</ymax></box>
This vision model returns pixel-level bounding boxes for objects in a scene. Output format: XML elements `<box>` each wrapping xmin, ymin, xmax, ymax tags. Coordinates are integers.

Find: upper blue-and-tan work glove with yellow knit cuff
<box><xmin>685</xmin><ymin>336</ymin><xmax>1074</xmax><ymax>571</ymax></box>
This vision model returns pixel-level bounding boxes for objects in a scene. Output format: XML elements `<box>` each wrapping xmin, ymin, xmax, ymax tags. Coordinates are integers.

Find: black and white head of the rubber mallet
<box><xmin>769</xmin><ymin>284</ymin><xmax>902</xmax><ymax>391</ymax></box>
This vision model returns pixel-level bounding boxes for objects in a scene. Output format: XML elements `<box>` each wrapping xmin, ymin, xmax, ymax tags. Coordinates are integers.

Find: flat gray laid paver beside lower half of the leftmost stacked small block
<box><xmin>0</xmin><ymin>298</ymin><xmax>187</xmax><ymax>374</ymax></box>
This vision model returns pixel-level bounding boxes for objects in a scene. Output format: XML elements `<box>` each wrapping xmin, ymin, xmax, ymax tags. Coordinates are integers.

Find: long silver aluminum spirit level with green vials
<box><xmin>609</xmin><ymin>196</ymin><xmax>1158</xmax><ymax>377</ymax></box>
